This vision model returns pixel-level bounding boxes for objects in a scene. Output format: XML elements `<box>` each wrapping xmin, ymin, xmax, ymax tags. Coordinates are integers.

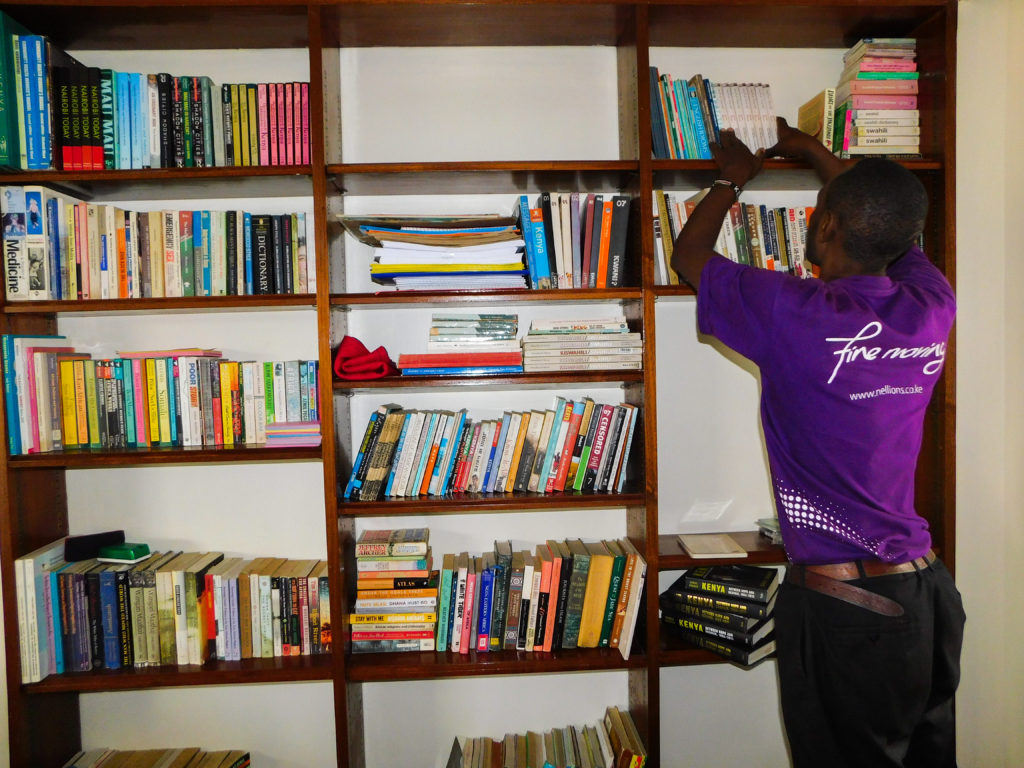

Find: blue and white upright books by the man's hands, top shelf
<box><xmin>649</xmin><ymin>67</ymin><xmax>778</xmax><ymax>160</ymax></box>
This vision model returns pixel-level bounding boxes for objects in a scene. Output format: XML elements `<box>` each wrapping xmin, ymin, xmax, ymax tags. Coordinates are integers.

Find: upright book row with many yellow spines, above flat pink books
<box><xmin>2</xmin><ymin>334</ymin><xmax>319</xmax><ymax>456</ymax></box>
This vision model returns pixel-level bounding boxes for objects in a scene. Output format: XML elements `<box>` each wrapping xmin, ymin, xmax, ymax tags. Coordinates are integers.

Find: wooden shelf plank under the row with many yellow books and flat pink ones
<box><xmin>7</xmin><ymin>445</ymin><xmax>322</xmax><ymax>469</ymax></box>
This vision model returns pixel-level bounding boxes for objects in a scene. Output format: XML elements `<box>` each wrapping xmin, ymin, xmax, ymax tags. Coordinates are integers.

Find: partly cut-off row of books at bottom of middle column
<box><xmin>445</xmin><ymin>707</ymin><xmax>647</xmax><ymax>768</ymax></box>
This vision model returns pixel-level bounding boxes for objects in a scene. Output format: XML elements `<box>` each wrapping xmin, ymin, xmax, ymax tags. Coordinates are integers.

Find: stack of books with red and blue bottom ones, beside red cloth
<box><xmin>398</xmin><ymin>312</ymin><xmax>522</xmax><ymax>376</ymax></box>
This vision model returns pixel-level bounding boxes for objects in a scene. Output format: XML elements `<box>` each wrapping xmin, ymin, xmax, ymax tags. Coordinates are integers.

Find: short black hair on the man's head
<box><xmin>824</xmin><ymin>158</ymin><xmax>928</xmax><ymax>269</ymax></box>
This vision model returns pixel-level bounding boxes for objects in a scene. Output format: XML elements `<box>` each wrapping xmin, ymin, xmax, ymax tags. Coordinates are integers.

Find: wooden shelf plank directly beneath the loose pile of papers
<box><xmin>331</xmin><ymin>288</ymin><xmax>643</xmax><ymax>309</ymax></box>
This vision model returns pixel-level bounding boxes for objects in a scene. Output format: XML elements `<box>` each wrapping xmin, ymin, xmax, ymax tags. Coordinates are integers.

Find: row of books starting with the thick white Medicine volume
<box><xmin>0</xmin><ymin>185</ymin><xmax>316</xmax><ymax>301</ymax></box>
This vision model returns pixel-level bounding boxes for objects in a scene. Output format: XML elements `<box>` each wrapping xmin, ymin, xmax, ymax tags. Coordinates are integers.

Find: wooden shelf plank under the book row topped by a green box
<box><xmin>23</xmin><ymin>654</ymin><xmax>333</xmax><ymax>694</ymax></box>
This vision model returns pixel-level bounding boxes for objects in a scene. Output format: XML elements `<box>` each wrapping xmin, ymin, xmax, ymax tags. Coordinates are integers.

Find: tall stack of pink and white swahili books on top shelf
<box><xmin>833</xmin><ymin>38</ymin><xmax>921</xmax><ymax>158</ymax></box>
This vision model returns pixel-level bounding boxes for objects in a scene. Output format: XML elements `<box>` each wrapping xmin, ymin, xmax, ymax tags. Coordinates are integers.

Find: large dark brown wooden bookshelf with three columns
<box><xmin>0</xmin><ymin>0</ymin><xmax>956</xmax><ymax>768</ymax></box>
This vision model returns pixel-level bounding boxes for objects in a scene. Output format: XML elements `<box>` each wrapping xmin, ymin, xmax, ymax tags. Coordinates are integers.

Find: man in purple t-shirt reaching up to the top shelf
<box><xmin>673</xmin><ymin>118</ymin><xmax>965</xmax><ymax>768</ymax></box>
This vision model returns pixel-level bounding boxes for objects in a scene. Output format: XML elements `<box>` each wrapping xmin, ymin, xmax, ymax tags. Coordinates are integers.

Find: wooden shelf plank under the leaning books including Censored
<box><xmin>338</xmin><ymin>494</ymin><xmax>644</xmax><ymax>517</ymax></box>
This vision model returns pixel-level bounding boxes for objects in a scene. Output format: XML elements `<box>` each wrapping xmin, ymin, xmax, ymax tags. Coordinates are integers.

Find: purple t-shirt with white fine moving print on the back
<box><xmin>697</xmin><ymin>248</ymin><xmax>955</xmax><ymax>563</ymax></box>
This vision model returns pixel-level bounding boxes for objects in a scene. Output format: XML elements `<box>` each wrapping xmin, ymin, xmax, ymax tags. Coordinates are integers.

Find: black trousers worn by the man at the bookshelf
<box><xmin>775</xmin><ymin>560</ymin><xmax>965</xmax><ymax>768</ymax></box>
